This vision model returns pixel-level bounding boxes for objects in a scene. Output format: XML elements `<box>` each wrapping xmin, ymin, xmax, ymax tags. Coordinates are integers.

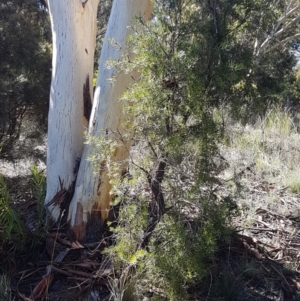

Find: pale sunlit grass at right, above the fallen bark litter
<box><xmin>222</xmin><ymin>107</ymin><xmax>300</xmax><ymax>202</ymax></box>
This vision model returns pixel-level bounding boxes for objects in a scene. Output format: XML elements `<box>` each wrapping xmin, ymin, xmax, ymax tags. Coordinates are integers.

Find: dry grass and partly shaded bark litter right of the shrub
<box><xmin>204</xmin><ymin>108</ymin><xmax>300</xmax><ymax>300</ymax></box>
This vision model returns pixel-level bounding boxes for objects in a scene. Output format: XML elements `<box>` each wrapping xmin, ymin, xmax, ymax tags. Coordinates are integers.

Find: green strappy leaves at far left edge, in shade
<box><xmin>0</xmin><ymin>176</ymin><xmax>24</xmax><ymax>248</ymax></box>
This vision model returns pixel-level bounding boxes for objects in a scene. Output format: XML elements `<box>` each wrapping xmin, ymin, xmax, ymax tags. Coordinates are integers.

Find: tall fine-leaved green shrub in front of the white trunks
<box><xmin>101</xmin><ymin>0</ymin><xmax>295</xmax><ymax>300</ymax></box>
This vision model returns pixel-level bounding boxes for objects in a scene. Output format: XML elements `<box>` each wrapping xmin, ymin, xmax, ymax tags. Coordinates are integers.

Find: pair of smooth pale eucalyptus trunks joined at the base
<box><xmin>45</xmin><ymin>0</ymin><xmax>152</xmax><ymax>240</ymax></box>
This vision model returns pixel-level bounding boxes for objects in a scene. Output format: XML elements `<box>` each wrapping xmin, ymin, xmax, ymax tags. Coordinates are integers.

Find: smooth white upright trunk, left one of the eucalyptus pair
<box><xmin>45</xmin><ymin>0</ymin><xmax>99</xmax><ymax>220</ymax></box>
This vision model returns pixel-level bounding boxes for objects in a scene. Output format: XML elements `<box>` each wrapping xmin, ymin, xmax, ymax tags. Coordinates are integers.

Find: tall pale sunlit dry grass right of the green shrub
<box><xmin>222</xmin><ymin>108</ymin><xmax>300</xmax><ymax>217</ymax></box>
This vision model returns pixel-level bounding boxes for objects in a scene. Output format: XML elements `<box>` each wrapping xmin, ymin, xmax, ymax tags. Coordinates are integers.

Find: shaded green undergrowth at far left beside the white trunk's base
<box><xmin>0</xmin><ymin>165</ymin><xmax>47</xmax><ymax>301</ymax></box>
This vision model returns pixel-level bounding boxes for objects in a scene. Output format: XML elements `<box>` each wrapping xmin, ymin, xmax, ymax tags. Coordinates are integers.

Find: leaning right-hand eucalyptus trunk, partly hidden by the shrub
<box><xmin>68</xmin><ymin>0</ymin><xmax>152</xmax><ymax>240</ymax></box>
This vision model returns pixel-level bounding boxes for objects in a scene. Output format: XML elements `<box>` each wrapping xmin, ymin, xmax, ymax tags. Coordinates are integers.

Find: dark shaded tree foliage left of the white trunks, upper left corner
<box><xmin>0</xmin><ymin>0</ymin><xmax>51</xmax><ymax>157</ymax></box>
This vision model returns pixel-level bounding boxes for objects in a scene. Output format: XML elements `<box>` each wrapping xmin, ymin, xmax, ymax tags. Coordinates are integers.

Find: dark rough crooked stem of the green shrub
<box><xmin>141</xmin><ymin>160</ymin><xmax>167</xmax><ymax>249</ymax></box>
